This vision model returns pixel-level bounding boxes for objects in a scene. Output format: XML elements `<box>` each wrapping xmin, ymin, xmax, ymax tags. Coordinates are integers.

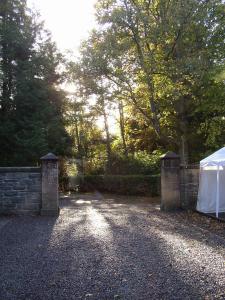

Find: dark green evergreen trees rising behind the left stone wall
<box><xmin>0</xmin><ymin>0</ymin><xmax>71</xmax><ymax>166</ymax></box>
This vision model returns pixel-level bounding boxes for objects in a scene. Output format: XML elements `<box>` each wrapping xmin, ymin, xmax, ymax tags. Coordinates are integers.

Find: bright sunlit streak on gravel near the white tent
<box><xmin>134</xmin><ymin>215</ymin><xmax>225</xmax><ymax>284</ymax></box>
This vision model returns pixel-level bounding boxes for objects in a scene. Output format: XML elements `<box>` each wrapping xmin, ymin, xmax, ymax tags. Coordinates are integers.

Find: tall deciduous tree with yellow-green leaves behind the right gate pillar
<box><xmin>91</xmin><ymin>0</ymin><xmax>225</xmax><ymax>163</ymax></box>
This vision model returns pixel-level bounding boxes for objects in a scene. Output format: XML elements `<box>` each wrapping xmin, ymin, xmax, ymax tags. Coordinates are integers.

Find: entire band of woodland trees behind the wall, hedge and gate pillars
<box><xmin>0</xmin><ymin>0</ymin><xmax>225</xmax><ymax>174</ymax></box>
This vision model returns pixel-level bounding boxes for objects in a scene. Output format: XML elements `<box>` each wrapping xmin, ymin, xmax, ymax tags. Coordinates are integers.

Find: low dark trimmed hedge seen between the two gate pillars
<box><xmin>76</xmin><ymin>175</ymin><xmax>160</xmax><ymax>196</ymax></box>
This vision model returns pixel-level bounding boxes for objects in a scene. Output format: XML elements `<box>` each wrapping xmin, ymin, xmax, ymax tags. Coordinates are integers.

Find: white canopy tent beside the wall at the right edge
<box><xmin>197</xmin><ymin>147</ymin><xmax>225</xmax><ymax>218</ymax></box>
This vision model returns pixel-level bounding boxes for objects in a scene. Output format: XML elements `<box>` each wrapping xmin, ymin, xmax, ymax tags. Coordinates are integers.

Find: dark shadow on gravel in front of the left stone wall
<box><xmin>0</xmin><ymin>216</ymin><xmax>57</xmax><ymax>300</ymax></box>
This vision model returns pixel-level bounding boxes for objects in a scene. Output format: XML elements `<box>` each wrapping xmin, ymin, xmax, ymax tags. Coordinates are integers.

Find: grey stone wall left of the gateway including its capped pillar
<box><xmin>0</xmin><ymin>153</ymin><xmax>59</xmax><ymax>216</ymax></box>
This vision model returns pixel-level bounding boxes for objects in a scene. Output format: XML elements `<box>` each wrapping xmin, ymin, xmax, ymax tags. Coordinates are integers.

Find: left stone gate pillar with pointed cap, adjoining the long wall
<box><xmin>41</xmin><ymin>153</ymin><xmax>59</xmax><ymax>216</ymax></box>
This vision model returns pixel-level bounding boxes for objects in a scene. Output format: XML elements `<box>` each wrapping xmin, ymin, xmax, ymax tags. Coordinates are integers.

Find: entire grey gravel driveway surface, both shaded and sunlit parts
<box><xmin>0</xmin><ymin>193</ymin><xmax>225</xmax><ymax>300</ymax></box>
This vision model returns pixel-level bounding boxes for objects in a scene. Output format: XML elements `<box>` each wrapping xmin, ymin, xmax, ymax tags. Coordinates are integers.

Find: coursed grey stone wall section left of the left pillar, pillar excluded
<box><xmin>0</xmin><ymin>168</ymin><xmax>41</xmax><ymax>214</ymax></box>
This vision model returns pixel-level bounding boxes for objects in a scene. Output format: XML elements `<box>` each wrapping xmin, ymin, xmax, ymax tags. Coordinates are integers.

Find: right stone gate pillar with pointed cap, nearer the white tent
<box><xmin>161</xmin><ymin>152</ymin><xmax>181</xmax><ymax>211</ymax></box>
